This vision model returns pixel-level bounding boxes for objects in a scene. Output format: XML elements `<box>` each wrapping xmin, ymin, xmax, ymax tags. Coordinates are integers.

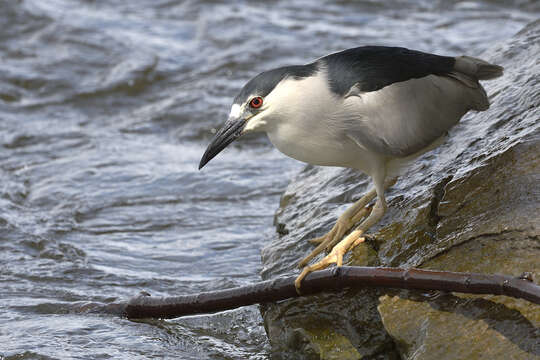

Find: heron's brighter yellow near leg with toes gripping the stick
<box><xmin>294</xmin><ymin>199</ymin><xmax>386</xmax><ymax>294</ymax></box>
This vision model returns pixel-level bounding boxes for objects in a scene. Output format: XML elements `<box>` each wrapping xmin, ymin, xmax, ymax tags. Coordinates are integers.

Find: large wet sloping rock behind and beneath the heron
<box><xmin>261</xmin><ymin>21</ymin><xmax>540</xmax><ymax>360</ymax></box>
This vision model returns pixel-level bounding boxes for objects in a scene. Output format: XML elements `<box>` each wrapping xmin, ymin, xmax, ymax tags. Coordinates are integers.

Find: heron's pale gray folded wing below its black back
<box><xmin>342</xmin><ymin>72</ymin><xmax>489</xmax><ymax>157</ymax></box>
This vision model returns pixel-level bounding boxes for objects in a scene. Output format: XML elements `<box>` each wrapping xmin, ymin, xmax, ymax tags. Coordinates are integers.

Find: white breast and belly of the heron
<box><xmin>266</xmin><ymin>70</ymin><xmax>378</xmax><ymax>173</ymax></box>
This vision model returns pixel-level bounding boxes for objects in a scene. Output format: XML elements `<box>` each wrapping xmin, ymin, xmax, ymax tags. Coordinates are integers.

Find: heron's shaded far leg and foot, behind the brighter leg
<box><xmin>298</xmin><ymin>207</ymin><xmax>371</xmax><ymax>268</ymax></box>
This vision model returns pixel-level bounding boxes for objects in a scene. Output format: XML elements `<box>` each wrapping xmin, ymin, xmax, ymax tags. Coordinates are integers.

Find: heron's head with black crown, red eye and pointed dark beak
<box><xmin>199</xmin><ymin>64</ymin><xmax>316</xmax><ymax>169</ymax></box>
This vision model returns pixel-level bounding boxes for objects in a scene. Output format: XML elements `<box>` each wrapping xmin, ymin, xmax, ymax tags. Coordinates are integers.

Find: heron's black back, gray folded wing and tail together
<box><xmin>321</xmin><ymin>46</ymin><xmax>503</xmax><ymax>157</ymax></box>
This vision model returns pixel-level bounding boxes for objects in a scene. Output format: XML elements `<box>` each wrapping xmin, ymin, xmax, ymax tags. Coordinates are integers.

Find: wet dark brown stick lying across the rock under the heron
<box><xmin>124</xmin><ymin>266</ymin><xmax>540</xmax><ymax>319</ymax></box>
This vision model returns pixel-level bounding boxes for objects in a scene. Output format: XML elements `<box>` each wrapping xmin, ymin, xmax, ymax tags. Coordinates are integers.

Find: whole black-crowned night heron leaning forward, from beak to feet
<box><xmin>199</xmin><ymin>46</ymin><xmax>503</xmax><ymax>290</ymax></box>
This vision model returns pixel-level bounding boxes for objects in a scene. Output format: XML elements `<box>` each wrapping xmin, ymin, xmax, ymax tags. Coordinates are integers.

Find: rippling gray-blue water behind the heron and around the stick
<box><xmin>0</xmin><ymin>0</ymin><xmax>540</xmax><ymax>359</ymax></box>
